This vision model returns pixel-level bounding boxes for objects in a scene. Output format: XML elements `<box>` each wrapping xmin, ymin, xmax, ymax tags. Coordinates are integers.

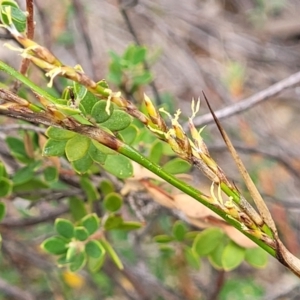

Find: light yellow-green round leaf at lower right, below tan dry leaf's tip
<box><xmin>222</xmin><ymin>241</ymin><xmax>245</xmax><ymax>271</ymax></box>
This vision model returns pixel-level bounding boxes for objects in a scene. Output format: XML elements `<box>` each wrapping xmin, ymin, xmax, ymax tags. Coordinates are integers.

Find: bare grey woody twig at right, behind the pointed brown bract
<box><xmin>188</xmin><ymin>72</ymin><xmax>300</xmax><ymax>128</ymax></box>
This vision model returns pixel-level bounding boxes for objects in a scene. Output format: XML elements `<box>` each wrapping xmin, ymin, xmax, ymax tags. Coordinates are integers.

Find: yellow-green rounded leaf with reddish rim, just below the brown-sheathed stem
<box><xmin>65</xmin><ymin>134</ymin><xmax>91</xmax><ymax>161</ymax></box>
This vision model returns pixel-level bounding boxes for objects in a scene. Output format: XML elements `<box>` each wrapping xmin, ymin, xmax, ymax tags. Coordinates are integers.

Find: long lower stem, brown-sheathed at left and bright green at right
<box><xmin>0</xmin><ymin>91</ymin><xmax>276</xmax><ymax>256</ymax></box>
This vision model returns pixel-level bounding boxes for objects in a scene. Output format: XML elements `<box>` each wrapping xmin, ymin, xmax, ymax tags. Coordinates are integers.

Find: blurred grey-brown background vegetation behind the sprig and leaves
<box><xmin>0</xmin><ymin>0</ymin><xmax>300</xmax><ymax>300</ymax></box>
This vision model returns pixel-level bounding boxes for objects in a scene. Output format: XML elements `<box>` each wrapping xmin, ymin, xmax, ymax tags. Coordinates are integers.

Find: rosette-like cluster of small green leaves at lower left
<box><xmin>42</xmin><ymin>190</ymin><xmax>142</xmax><ymax>272</ymax></box>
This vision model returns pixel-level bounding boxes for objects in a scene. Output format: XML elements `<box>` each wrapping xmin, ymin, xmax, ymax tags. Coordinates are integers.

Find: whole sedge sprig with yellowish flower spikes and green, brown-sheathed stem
<box><xmin>0</xmin><ymin>34</ymin><xmax>300</xmax><ymax>276</ymax></box>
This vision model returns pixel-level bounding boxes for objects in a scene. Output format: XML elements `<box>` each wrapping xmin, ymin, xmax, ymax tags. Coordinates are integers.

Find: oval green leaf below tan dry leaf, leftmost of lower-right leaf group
<box><xmin>193</xmin><ymin>228</ymin><xmax>224</xmax><ymax>256</ymax></box>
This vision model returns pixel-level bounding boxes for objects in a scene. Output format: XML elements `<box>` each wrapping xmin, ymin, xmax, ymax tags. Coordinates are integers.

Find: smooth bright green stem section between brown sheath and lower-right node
<box><xmin>118</xmin><ymin>144</ymin><xmax>276</xmax><ymax>257</ymax></box>
